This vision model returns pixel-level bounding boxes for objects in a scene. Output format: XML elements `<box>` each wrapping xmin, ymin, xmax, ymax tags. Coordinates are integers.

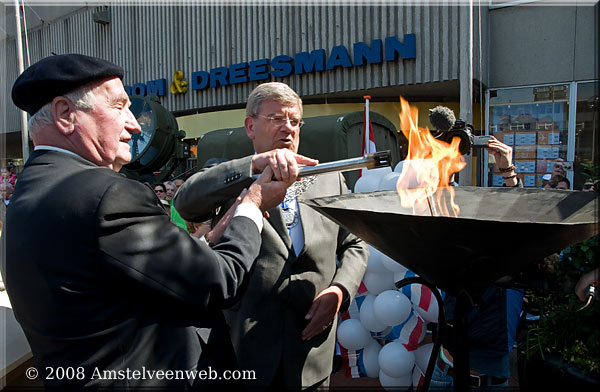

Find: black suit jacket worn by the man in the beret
<box><xmin>4</xmin><ymin>151</ymin><xmax>261</xmax><ymax>389</ymax></box>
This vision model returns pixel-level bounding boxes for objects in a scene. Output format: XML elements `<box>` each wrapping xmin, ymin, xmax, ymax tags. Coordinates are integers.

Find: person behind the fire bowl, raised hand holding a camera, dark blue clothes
<box><xmin>430</xmin><ymin>136</ymin><xmax>524</xmax><ymax>390</ymax></box>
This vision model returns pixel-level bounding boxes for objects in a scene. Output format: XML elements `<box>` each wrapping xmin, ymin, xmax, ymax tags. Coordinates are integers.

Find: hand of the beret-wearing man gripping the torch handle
<box><xmin>242</xmin><ymin>166</ymin><xmax>298</xmax><ymax>213</ymax></box>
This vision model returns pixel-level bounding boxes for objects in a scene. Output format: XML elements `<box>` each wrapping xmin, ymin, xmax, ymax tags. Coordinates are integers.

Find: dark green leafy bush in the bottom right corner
<box><xmin>522</xmin><ymin>235</ymin><xmax>600</xmax><ymax>374</ymax></box>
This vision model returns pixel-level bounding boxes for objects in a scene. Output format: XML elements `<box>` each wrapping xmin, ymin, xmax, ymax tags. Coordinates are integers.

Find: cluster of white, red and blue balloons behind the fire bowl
<box><xmin>337</xmin><ymin>162</ymin><xmax>438</xmax><ymax>391</ymax></box>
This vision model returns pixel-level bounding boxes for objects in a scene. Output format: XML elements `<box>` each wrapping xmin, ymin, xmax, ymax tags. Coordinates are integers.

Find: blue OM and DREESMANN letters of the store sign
<box><xmin>125</xmin><ymin>34</ymin><xmax>417</xmax><ymax>96</ymax></box>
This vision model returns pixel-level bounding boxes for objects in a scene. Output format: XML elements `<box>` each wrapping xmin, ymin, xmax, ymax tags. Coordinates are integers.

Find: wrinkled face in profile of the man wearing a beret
<box><xmin>76</xmin><ymin>78</ymin><xmax>141</xmax><ymax>166</ymax></box>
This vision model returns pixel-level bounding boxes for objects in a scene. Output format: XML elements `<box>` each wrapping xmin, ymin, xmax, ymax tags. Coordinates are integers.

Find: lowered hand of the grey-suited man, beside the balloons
<box><xmin>302</xmin><ymin>285</ymin><xmax>344</xmax><ymax>340</ymax></box>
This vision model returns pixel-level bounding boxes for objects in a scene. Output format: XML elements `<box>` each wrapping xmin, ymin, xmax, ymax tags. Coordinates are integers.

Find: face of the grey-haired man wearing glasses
<box><xmin>245</xmin><ymin>99</ymin><xmax>302</xmax><ymax>154</ymax></box>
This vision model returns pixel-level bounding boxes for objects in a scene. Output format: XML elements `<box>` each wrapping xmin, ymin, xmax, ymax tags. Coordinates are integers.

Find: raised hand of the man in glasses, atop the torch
<box><xmin>252</xmin><ymin>149</ymin><xmax>319</xmax><ymax>181</ymax></box>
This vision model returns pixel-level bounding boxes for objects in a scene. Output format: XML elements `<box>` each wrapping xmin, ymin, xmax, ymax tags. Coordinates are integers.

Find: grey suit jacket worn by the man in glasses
<box><xmin>174</xmin><ymin>157</ymin><xmax>368</xmax><ymax>388</ymax></box>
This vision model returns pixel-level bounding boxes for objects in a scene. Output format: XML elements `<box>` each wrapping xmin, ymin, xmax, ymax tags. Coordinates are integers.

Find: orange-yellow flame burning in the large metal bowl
<box><xmin>396</xmin><ymin>97</ymin><xmax>466</xmax><ymax>217</ymax></box>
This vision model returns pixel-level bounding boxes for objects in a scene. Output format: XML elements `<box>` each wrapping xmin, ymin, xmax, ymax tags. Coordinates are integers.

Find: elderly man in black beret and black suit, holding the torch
<box><xmin>3</xmin><ymin>54</ymin><xmax>297</xmax><ymax>389</ymax></box>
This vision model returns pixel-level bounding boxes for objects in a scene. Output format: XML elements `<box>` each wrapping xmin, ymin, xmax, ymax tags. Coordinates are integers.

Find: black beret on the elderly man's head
<box><xmin>12</xmin><ymin>54</ymin><xmax>124</xmax><ymax>115</ymax></box>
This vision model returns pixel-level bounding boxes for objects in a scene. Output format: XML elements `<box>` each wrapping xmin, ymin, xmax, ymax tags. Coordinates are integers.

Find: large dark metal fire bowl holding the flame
<box><xmin>304</xmin><ymin>187</ymin><xmax>598</xmax><ymax>293</ymax></box>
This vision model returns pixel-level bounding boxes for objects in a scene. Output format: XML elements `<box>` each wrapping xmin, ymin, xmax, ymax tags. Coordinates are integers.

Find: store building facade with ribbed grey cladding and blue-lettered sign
<box><xmin>2</xmin><ymin>1</ymin><xmax>599</xmax><ymax>186</ymax></box>
